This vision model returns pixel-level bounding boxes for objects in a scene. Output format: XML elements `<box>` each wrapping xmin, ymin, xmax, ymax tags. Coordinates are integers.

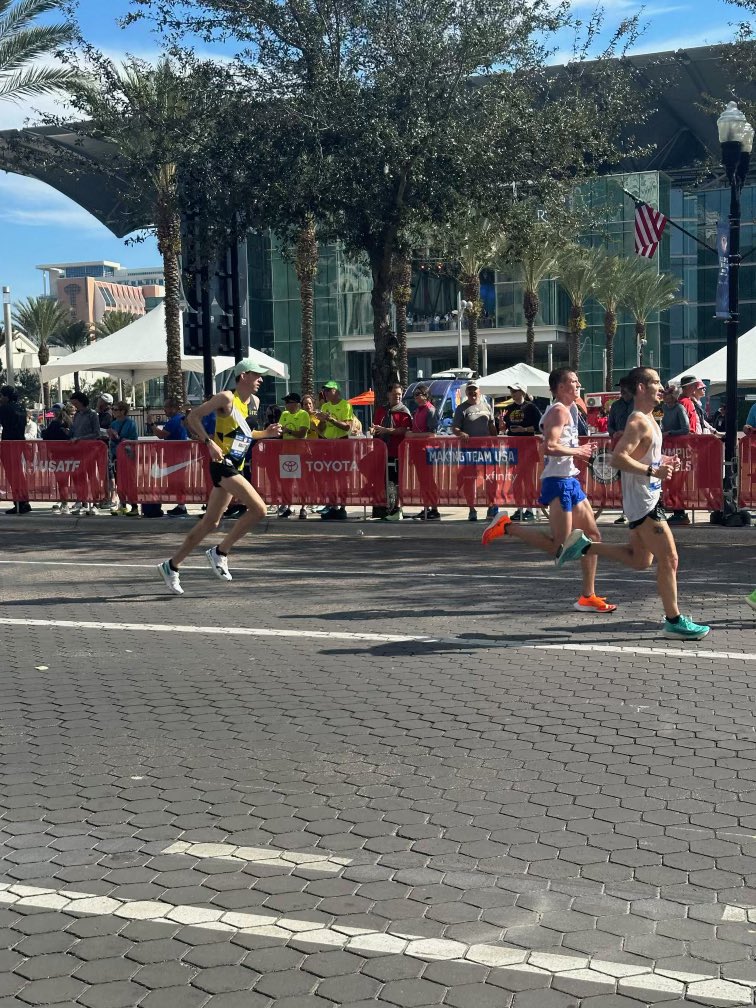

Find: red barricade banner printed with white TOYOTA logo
<box><xmin>251</xmin><ymin>437</ymin><xmax>386</xmax><ymax>506</ymax></box>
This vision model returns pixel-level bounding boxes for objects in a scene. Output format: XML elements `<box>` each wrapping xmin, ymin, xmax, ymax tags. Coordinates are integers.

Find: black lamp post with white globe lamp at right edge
<box><xmin>717</xmin><ymin>102</ymin><xmax>754</xmax><ymax>514</ymax></box>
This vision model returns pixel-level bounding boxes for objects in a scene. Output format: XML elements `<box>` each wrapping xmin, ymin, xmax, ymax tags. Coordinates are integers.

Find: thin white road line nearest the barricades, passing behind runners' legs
<box><xmin>0</xmin><ymin>559</ymin><xmax>743</xmax><ymax>594</ymax></box>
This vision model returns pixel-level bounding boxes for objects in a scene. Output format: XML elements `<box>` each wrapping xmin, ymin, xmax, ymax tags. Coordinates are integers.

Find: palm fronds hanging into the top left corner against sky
<box><xmin>0</xmin><ymin>0</ymin><xmax>79</xmax><ymax>101</ymax></box>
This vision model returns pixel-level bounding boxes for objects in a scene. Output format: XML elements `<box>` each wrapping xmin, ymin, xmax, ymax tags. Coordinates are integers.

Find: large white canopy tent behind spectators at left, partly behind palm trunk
<box><xmin>40</xmin><ymin>304</ymin><xmax>276</xmax><ymax>385</ymax></box>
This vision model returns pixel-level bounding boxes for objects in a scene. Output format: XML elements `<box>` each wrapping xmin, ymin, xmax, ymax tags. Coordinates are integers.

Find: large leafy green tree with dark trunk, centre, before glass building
<box><xmin>133</xmin><ymin>0</ymin><xmax>640</xmax><ymax>399</ymax></box>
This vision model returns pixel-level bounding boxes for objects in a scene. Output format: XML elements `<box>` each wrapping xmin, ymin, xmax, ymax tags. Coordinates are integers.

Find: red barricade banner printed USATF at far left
<box><xmin>0</xmin><ymin>440</ymin><xmax>108</xmax><ymax>502</ymax></box>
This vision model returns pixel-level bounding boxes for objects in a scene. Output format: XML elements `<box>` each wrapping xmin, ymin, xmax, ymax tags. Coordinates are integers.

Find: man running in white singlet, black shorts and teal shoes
<box><xmin>556</xmin><ymin>368</ymin><xmax>711</xmax><ymax>640</ymax></box>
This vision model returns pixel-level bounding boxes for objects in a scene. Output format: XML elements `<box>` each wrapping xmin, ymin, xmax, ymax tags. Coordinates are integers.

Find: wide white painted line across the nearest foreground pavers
<box><xmin>0</xmin><ymin>883</ymin><xmax>756</xmax><ymax>1005</ymax></box>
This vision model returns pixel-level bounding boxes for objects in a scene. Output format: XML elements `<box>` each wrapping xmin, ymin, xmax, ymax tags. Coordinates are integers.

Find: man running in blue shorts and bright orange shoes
<box><xmin>482</xmin><ymin>368</ymin><xmax>617</xmax><ymax>613</ymax></box>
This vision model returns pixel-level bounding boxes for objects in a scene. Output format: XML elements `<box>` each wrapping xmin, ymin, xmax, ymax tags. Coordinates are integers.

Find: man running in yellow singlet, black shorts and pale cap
<box><xmin>157</xmin><ymin>359</ymin><xmax>281</xmax><ymax>595</ymax></box>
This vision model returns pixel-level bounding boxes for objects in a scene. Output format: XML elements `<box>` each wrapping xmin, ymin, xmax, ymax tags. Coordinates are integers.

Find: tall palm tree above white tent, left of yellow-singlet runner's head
<box><xmin>74</xmin><ymin>58</ymin><xmax>190</xmax><ymax>402</ymax></box>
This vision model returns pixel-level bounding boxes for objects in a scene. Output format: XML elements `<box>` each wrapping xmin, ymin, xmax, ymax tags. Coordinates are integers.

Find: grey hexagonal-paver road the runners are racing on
<box><xmin>0</xmin><ymin>519</ymin><xmax>756</xmax><ymax>1008</ymax></box>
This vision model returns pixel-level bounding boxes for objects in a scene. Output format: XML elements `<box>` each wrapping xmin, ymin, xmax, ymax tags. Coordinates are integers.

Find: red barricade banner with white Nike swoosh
<box><xmin>116</xmin><ymin>440</ymin><xmax>212</xmax><ymax>504</ymax></box>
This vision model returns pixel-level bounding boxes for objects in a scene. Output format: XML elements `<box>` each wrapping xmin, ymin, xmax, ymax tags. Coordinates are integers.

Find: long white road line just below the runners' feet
<box><xmin>0</xmin><ymin>617</ymin><xmax>756</xmax><ymax>661</ymax></box>
